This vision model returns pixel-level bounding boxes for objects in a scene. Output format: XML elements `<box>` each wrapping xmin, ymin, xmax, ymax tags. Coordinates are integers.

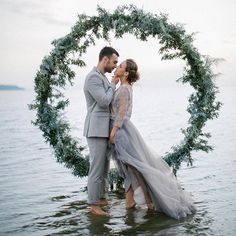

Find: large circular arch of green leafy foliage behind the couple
<box><xmin>30</xmin><ymin>5</ymin><xmax>221</xmax><ymax>177</ymax></box>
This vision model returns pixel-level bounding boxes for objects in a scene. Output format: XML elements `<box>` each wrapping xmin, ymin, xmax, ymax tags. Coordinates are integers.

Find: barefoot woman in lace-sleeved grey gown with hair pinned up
<box><xmin>109</xmin><ymin>59</ymin><xmax>196</xmax><ymax>219</ymax></box>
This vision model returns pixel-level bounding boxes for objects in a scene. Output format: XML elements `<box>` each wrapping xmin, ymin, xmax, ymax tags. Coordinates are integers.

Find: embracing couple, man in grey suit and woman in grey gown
<box><xmin>84</xmin><ymin>47</ymin><xmax>196</xmax><ymax>219</ymax></box>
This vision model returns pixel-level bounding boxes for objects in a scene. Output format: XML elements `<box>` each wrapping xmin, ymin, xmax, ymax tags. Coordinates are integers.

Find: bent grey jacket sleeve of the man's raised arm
<box><xmin>88</xmin><ymin>76</ymin><xmax>116</xmax><ymax>108</ymax></box>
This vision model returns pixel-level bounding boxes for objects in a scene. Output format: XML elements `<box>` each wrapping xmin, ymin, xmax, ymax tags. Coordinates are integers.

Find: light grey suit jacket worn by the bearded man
<box><xmin>84</xmin><ymin>67</ymin><xmax>116</xmax><ymax>137</ymax></box>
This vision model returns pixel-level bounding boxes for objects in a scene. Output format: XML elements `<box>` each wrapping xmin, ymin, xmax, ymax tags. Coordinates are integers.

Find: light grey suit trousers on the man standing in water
<box><xmin>87</xmin><ymin>137</ymin><xmax>109</xmax><ymax>204</ymax></box>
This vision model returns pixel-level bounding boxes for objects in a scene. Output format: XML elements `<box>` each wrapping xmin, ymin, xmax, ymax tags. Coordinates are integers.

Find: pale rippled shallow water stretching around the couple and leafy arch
<box><xmin>0</xmin><ymin>86</ymin><xmax>236</xmax><ymax>236</ymax></box>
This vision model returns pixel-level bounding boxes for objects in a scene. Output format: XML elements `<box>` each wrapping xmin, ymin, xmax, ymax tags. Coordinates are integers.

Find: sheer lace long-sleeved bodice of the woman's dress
<box><xmin>111</xmin><ymin>84</ymin><xmax>133</xmax><ymax>127</ymax></box>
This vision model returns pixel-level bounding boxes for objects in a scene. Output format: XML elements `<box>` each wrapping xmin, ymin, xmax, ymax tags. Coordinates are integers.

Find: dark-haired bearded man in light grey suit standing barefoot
<box><xmin>84</xmin><ymin>47</ymin><xmax>119</xmax><ymax>215</ymax></box>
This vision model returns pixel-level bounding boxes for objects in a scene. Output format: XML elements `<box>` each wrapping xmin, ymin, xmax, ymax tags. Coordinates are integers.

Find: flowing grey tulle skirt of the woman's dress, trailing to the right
<box><xmin>111</xmin><ymin>120</ymin><xmax>196</xmax><ymax>219</ymax></box>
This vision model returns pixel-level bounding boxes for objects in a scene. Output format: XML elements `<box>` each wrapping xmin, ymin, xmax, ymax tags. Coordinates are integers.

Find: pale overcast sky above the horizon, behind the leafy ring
<box><xmin>0</xmin><ymin>0</ymin><xmax>236</xmax><ymax>88</ymax></box>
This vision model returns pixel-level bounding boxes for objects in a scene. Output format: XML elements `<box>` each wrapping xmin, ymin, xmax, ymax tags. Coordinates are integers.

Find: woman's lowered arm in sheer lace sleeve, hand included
<box><xmin>110</xmin><ymin>87</ymin><xmax>130</xmax><ymax>144</ymax></box>
